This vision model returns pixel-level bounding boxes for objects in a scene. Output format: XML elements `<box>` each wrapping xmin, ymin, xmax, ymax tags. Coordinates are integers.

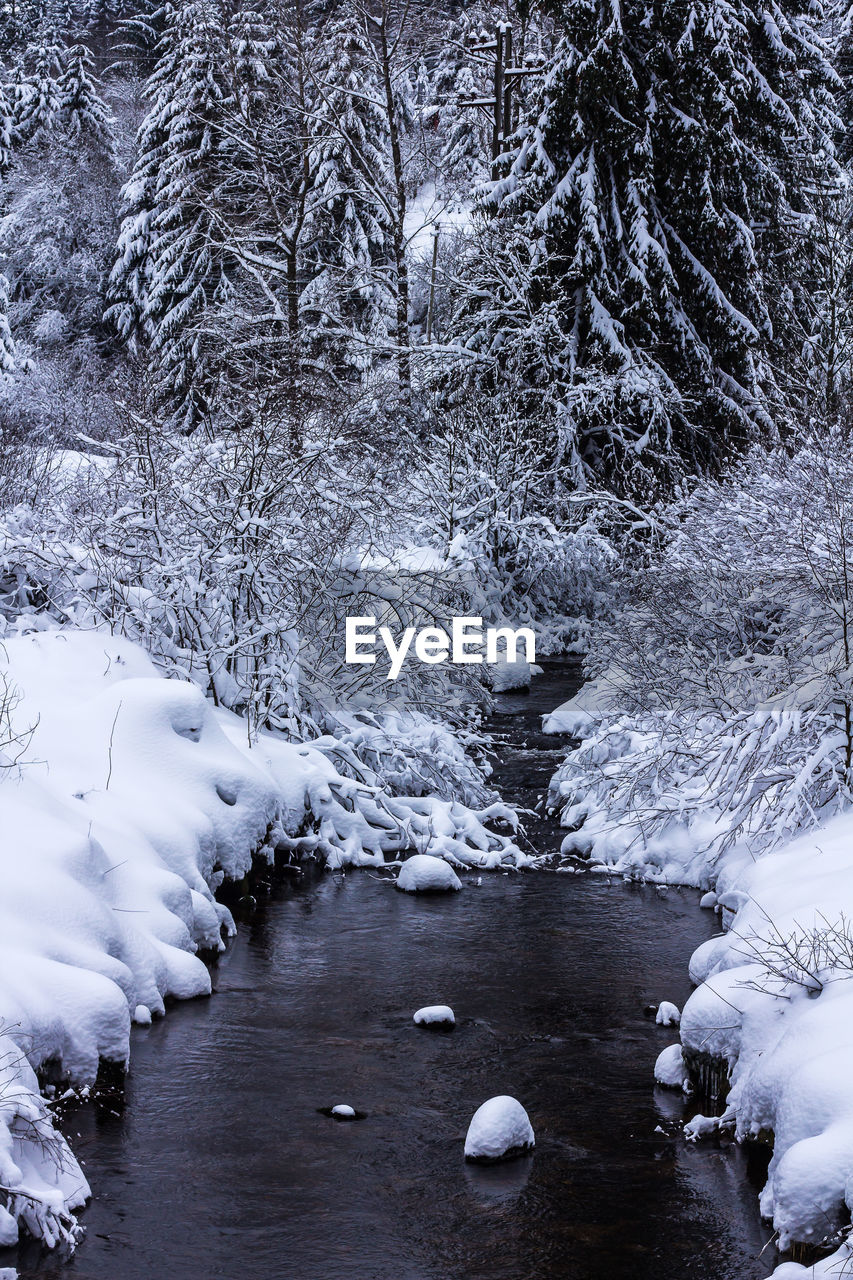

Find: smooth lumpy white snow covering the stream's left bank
<box><xmin>0</xmin><ymin>630</ymin><xmax>526</xmax><ymax>1244</ymax></box>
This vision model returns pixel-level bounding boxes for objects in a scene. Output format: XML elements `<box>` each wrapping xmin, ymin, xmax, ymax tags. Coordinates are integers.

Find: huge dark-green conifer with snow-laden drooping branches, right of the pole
<box><xmin>456</xmin><ymin>0</ymin><xmax>834</xmax><ymax>499</ymax></box>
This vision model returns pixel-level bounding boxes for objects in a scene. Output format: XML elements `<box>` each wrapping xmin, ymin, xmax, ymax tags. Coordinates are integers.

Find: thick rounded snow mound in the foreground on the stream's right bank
<box><xmin>681</xmin><ymin>815</ymin><xmax>853</xmax><ymax>1249</ymax></box>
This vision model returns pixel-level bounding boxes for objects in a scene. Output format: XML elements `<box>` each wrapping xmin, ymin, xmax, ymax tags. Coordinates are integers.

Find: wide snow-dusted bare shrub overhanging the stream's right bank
<box><xmin>551</xmin><ymin>435</ymin><xmax>853</xmax><ymax>883</ymax></box>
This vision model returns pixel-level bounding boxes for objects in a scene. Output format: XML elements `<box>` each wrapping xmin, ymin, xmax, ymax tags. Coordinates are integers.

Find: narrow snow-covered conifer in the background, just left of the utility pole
<box><xmin>304</xmin><ymin>3</ymin><xmax>394</xmax><ymax>371</ymax></box>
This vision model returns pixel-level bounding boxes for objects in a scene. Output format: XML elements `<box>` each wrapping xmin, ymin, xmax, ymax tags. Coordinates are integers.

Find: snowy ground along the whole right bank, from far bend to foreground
<box><xmin>544</xmin><ymin>686</ymin><xmax>853</xmax><ymax>1280</ymax></box>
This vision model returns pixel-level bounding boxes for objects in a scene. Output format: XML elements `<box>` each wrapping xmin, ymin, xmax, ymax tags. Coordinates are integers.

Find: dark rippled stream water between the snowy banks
<box><xmin>8</xmin><ymin>666</ymin><xmax>771</xmax><ymax>1280</ymax></box>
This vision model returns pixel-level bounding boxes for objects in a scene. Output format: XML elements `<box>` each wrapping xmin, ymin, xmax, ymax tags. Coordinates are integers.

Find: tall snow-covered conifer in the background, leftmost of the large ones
<box><xmin>108</xmin><ymin>0</ymin><xmax>232</xmax><ymax>430</ymax></box>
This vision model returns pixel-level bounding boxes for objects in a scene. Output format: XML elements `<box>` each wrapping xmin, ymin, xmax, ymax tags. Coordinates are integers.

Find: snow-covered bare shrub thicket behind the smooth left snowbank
<box><xmin>0</xmin><ymin>415</ymin><xmax>499</xmax><ymax>808</ymax></box>
